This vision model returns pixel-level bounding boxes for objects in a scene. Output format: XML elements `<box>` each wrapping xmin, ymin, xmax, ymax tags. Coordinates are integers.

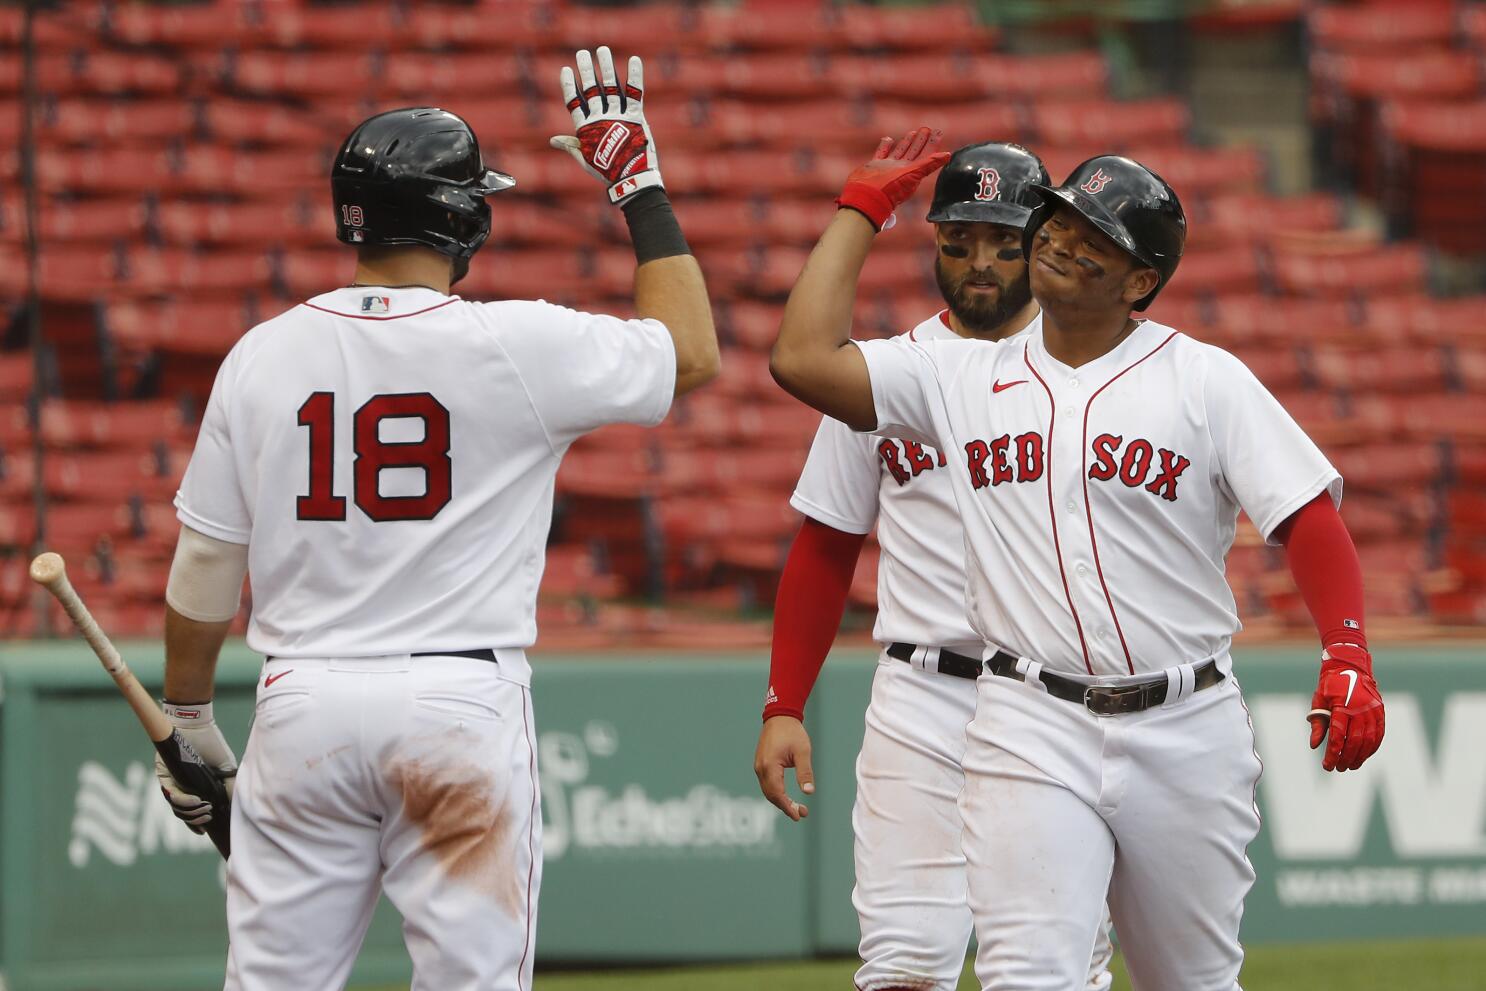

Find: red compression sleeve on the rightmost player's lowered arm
<box><xmin>1275</xmin><ymin>492</ymin><xmax>1367</xmax><ymax>648</ymax></box>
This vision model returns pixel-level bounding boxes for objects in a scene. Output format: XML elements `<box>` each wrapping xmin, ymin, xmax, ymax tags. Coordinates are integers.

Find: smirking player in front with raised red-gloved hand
<box><xmin>773</xmin><ymin>129</ymin><xmax>1383</xmax><ymax>991</ymax></box>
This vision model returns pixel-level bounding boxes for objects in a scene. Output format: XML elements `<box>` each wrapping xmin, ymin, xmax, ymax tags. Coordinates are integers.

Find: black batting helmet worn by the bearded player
<box><xmin>926</xmin><ymin>141</ymin><xmax>1052</xmax><ymax>227</ymax></box>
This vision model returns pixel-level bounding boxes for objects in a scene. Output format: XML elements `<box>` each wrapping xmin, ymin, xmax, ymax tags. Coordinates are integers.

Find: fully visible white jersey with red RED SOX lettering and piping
<box><xmin>857</xmin><ymin>321</ymin><xmax>1342</xmax><ymax>676</ymax></box>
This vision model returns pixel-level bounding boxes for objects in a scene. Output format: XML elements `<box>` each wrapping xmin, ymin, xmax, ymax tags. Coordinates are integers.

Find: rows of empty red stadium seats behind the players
<box><xmin>0</xmin><ymin>0</ymin><xmax>1486</xmax><ymax>645</ymax></box>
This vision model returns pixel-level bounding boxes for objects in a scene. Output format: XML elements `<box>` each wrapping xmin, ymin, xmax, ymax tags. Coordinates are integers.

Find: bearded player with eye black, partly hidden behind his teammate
<box><xmin>755</xmin><ymin>143</ymin><xmax>1112</xmax><ymax>991</ymax></box>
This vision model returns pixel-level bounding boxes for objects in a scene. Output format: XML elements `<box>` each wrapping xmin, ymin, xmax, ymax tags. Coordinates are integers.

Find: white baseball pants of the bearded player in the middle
<box><xmin>851</xmin><ymin>654</ymin><xmax>1113</xmax><ymax>991</ymax></box>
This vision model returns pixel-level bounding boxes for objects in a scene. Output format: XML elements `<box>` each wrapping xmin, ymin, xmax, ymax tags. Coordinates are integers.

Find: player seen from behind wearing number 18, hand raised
<box><xmin>150</xmin><ymin>48</ymin><xmax>718</xmax><ymax>991</ymax></box>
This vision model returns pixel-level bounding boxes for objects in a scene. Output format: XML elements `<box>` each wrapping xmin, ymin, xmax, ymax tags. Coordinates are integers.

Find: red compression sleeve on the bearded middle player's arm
<box><xmin>764</xmin><ymin>517</ymin><xmax>866</xmax><ymax>719</ymax></box>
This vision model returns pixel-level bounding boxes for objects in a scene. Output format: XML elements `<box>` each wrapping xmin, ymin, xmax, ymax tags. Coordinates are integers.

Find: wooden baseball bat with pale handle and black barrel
<box><xmin>31</xmin><ymin>551</ymin><xmax>232</xmax><ymax>860</ymax></box>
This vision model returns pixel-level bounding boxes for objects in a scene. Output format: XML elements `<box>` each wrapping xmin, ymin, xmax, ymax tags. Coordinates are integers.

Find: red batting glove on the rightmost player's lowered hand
<box><xmin>1306</xmin><ymin>643</ymin><xmax>1383</xmax><ymax>771</ymax></box>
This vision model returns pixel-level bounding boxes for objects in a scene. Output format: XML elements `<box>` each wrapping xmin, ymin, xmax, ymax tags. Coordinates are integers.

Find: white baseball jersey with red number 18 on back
<box><xmin>175</xmin><ymin>287</ymin><xmax>676</xmax><ymax>676</ymax></box>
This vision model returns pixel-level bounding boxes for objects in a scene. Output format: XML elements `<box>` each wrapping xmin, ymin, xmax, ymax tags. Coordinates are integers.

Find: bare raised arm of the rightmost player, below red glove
<box><xmin>770</xmin><ymin>209</ymin><xmax>877</xmax><ymax>429</ymax></box>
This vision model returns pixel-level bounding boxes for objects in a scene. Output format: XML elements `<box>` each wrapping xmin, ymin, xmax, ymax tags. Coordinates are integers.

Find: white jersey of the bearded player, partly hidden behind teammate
<box><xmin>789</xmin><ymin>311</ymin><xmax>1042</xmax><ymax>648</ymax></box>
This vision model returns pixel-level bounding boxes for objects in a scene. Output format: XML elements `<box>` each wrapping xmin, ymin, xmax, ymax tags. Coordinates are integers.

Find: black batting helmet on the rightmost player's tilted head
<box><xmin>1022</xmin><ymin>155</ymin><xmax>1187</xmax><ymax>311</ymax></box>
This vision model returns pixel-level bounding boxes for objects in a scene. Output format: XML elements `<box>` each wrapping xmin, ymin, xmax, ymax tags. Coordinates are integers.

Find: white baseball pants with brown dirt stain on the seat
<box><xmin>226</xmin><ymin>654</ymin><xmax>542</xmax><ymax>991</ymax></box>
